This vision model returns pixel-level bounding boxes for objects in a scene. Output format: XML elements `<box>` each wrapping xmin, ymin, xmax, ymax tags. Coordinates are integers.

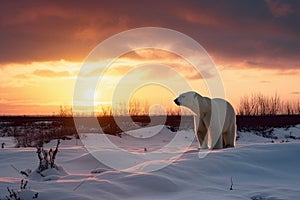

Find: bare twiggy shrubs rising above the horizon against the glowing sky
<box><xmin>58</xmin><ymin>93</ymin><xmax>300</xmax><ymax>117</ymax></box>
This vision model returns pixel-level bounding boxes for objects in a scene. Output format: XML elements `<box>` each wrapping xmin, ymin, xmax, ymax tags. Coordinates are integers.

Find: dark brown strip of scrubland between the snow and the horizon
<box><xmin>0</xmin><ymin>115</ymin><xmax>300</xmax><ymax>139</ymax></box>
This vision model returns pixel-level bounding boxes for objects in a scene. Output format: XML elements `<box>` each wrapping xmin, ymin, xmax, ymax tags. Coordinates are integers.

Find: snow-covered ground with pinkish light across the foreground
<box><xmin>0</xmin><ymin>125</ymin><xmax>300</xmax><ymax>200</ymax></box>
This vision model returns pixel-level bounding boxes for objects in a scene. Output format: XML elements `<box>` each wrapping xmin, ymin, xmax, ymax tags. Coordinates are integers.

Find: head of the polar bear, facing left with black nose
<box><xmin>174</xmin><ymin>91</ymin><xmax>200</xmax><ymax>113</ymax></box>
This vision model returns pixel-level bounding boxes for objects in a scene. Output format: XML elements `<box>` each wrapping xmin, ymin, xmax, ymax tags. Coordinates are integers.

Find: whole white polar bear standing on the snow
<box><xmin>174</xmin><ymin>91</ymin><xmax>236</xmax><ymax>149</ymax></box>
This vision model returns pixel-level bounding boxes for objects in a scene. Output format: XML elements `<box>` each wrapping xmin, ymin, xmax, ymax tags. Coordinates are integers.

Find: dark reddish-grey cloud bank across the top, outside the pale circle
<box><xmin>0</xmin><ymin>0</ymin><xmax>300</xmax><ymax>68</ymax></box>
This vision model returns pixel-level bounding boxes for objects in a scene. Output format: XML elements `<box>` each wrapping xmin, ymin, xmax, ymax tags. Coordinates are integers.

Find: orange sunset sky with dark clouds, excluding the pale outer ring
<box><xmin>0</xmin><ymin>0</ymin><xmax>300</xmax><ymax>115</ymax></box>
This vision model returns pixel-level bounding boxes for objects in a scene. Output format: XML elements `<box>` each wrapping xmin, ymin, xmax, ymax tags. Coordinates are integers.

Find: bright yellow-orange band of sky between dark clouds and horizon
<box><xmin>0</xmin><ymin>50</ymin><xmax>300</xmax><ymax>115</ymax></box>
